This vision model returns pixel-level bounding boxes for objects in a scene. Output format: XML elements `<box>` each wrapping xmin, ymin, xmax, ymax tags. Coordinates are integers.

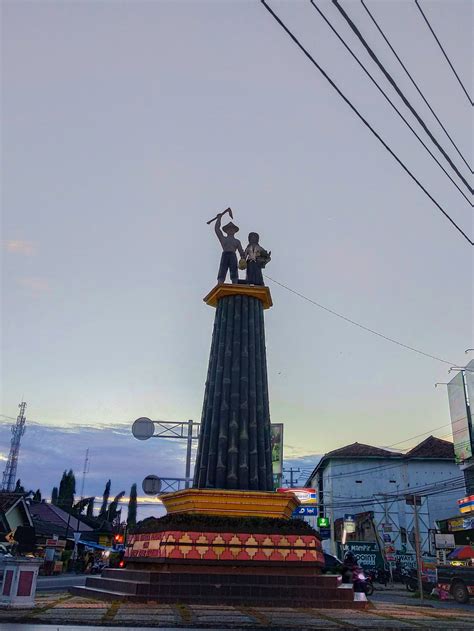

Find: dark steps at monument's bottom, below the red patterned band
<box><xmin>70</xmin><ymin>564</ymin><xmax>367</xmax><ymax>609</ymax></box>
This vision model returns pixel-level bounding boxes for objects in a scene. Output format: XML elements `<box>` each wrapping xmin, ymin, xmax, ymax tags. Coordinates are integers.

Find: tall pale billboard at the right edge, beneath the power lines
<box><xmin>448</xmin><ymin>370</ymin><xmax>473</xmax><ymax>464</ymax></box>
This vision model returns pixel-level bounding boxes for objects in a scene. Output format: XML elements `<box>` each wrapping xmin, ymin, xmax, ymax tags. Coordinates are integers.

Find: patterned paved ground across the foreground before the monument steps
<box><xmin>0</xmin><ymin>593</ymin><xmax>474</xmax><ymax>631</ymax></box>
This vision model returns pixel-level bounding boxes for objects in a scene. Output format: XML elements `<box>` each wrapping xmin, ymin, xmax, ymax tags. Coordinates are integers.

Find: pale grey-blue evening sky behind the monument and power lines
<box><xmin>0</xmin><ymin>0</ymin><xmax>474</xmax><ymax>520</ymax></box>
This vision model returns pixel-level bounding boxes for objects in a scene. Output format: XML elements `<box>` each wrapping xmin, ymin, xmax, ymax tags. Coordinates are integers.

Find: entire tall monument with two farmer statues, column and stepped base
<box><xmin>71</xmin><ymin>208</ymin><xmax>364</xmax><ymax>608</ymax></box>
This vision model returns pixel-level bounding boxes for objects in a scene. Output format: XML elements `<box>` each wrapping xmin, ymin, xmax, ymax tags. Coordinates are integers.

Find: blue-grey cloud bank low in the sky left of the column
<box><xmin>0</xmin><ymin>420</ymin><xmax>186</xmax><ymax>519</ymax></box>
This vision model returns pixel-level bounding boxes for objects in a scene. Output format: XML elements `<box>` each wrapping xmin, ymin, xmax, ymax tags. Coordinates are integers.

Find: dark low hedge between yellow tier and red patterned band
<box><xmin>130</xmin><ymin>513</ymin><xmax>318</xmax><ymax>535</ymax></box>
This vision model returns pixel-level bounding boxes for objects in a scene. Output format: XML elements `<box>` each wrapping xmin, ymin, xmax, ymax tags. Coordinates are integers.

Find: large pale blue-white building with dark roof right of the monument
<box><xmin>306</xmin><ymin>436</ymin><xmax>464</xmax><ymax>560</ymax></box>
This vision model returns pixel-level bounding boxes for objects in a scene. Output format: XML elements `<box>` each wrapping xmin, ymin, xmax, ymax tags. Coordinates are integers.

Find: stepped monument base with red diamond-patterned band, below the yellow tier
<box><xmin>70</xmin><ymin>508</ymin><xmax>367</xmax><ymax>608</ymax></box>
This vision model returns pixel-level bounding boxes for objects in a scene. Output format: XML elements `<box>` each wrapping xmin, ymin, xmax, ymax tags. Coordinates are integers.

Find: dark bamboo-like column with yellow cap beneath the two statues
<box><xmin>194</xmin><ymin>285</ymin><xmax>273</xmax><ymax>491</ymax></box>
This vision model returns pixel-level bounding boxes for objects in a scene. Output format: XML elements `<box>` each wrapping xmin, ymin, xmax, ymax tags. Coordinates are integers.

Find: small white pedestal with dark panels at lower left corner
<box><xmin>0</xmin><ymin>557</ymin><xmax>42</xmax><ymax>607</ymax></box>
